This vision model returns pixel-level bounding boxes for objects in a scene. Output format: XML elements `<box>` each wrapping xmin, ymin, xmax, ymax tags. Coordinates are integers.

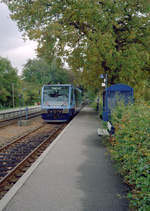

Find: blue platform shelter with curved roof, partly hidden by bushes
<box><xmin>102</xmin><ymin>84</ymin><xmax>133</xmax><ymax>121</ymax></box>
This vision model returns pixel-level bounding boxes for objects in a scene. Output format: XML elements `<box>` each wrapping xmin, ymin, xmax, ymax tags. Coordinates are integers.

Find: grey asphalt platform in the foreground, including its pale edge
<box><xmin>0</xmin><ymin>107</ymin><xmax>129</xmax><ymax>211</ymax></box>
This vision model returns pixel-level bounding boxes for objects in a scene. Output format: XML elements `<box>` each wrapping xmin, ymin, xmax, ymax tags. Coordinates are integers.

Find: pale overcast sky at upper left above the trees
<box><xmin>0</xmin><ymin>3</ymin><xmax>37</xmax><ymax>74</ymax></box>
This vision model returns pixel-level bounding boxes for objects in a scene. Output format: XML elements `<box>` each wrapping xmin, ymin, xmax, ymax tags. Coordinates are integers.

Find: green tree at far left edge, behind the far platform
<box><xmin>0</xmin><ymin>57</ymin><xmax>20</xmax><ymax>107</ymax></box>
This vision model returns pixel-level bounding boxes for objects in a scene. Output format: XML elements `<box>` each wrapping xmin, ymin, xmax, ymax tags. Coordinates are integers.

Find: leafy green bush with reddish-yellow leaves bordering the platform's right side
<box><xmin>110</xmin><ymin>103</ymin><xmax>150</xmax><ymax>211</ymax></box>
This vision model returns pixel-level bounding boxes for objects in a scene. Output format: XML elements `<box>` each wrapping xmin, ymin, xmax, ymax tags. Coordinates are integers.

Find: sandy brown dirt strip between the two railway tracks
<box><xmin>0</xmin><ymin>117</ymin><xmax>44</xmax><ymax>148</ymax></box>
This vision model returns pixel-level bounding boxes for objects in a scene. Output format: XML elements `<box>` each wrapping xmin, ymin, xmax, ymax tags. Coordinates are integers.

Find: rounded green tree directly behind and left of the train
<box><xmin>20</xmin><ymin>58</ymin><xmax>72</xmax><ymax>105</ymax></box>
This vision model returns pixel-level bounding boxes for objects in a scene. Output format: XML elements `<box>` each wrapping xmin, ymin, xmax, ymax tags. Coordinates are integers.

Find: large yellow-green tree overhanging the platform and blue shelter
<box><xmin>3</xmin><ymin>0</ymin><xmax>150</xmax><ymax>98</ymax></box>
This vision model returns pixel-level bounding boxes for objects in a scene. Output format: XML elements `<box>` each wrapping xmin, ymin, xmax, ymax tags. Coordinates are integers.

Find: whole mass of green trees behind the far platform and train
<box><xmin>0</xmin><ymin>57</ymin><xmax>73</xmax><ymax>109</ymax></box>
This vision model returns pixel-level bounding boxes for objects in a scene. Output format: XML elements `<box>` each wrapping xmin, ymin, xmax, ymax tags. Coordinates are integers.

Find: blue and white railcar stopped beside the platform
<box><xmin>41</xmin><ymin>84</ymin><xmax>81</xmax><ymax>122</ymax></box>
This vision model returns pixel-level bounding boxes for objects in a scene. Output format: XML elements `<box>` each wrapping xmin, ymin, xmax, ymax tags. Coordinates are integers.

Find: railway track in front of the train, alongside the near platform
<box><xmin>0</xmin><ymin>124</ymin><xmax>66</xmax><ymax>199</ymax></box>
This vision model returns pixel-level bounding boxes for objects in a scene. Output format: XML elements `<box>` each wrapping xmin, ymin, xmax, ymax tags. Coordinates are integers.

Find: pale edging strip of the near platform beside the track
<box><xmin>0</xmin><ymin>120</ymin><xmax>73</xmax><ymax>211</ymax></box>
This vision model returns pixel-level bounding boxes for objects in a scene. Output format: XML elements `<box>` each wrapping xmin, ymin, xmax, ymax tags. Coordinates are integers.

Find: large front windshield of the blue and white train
<box><xmin>43</xmin><ymin>86</ymin><xmax>69</xmax><ymax>106</ymax></box>
